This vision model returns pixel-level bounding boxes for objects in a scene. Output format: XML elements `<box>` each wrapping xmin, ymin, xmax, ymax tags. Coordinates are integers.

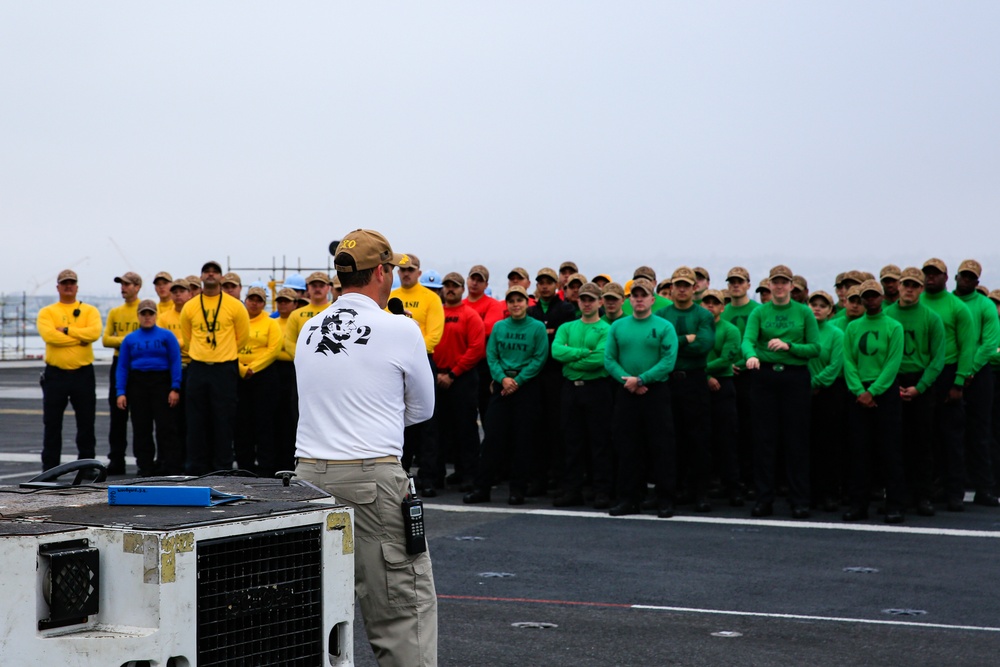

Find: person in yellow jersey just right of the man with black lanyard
<box><xmin>233</xmin><ymin>287</ymin><xmax>284</xmax><ymax>477</ymax></box>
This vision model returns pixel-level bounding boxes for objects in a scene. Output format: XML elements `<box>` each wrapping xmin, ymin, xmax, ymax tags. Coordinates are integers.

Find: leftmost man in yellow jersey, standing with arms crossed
<box><xmin>36</xmin><ymin>269</ymin><xmax>101</xmax><ymax>470</ymax></box>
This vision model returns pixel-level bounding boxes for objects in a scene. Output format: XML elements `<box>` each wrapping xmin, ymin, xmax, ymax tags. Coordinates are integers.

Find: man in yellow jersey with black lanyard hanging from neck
<box><xmin>181</xmin><ymin>262</ymin><xmax>250</xmax><ymax>475</ymax></box>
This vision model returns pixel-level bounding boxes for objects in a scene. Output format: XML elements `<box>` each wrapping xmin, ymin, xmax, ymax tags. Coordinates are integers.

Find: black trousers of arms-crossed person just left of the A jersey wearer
<box><xmin>561</xmin><ymin>378</ymin><xmax>615</xmax><ymax>497</ymax></box>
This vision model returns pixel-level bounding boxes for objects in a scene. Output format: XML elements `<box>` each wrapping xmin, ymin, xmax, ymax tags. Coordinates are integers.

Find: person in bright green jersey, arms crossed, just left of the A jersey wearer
<box><xmin>552</xmin><ymin>278</ymin><xmax>615</xmax><ymax>509</ymax></box>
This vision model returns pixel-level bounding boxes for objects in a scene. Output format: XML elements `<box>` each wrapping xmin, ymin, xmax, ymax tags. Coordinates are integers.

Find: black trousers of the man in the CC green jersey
<box><xmin>847</xmin><ymin>383</ymin><xmax>907</xmax><ymax>510</ymax></box>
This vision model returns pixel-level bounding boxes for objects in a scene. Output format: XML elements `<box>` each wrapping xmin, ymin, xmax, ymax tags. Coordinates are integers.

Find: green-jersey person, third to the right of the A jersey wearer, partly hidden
<box><xmin>701</xmin><ymin>289</ymin><xmax>743</xmax><ymax>507</ymax></box>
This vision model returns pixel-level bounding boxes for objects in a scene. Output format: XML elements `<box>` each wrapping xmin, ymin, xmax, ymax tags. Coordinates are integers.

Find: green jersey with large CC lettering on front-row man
<box><xmin>844</xmin><ymin>312</ymin><xmax>903</xmax><ymax>396</ymax></box>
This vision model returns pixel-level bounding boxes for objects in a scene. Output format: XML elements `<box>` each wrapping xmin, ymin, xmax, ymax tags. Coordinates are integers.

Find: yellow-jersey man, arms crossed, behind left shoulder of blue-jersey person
<box><xmin>102</xmin><ymin>271</ymin><xmax>142</xmax><ymax>475</ymax></box>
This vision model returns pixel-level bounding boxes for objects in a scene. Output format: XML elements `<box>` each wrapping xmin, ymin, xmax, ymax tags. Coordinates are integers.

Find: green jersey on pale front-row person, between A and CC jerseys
<box><xmin>742</xmin><ymin>301</ymin><xmax>819</xmax><ymax>366</ymax></box>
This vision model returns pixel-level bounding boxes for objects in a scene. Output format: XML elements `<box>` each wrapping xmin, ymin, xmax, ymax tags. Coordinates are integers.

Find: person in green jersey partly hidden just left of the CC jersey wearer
<box><xmin>806</xmin><ymin>291</ymin><xmax>847</xmax><ymax>512</ymax></box>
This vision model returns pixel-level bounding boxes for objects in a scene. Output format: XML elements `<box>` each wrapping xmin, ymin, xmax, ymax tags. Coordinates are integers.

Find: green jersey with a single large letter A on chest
<box><xmin>604</xmin><ymin>315</ymin><xmax>677</xmax><ymax>384</ymax></box>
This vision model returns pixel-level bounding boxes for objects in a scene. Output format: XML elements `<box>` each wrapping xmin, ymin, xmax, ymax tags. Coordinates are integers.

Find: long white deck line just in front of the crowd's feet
<box><xmin>424</xmin><ymin>501</ymin><xmax>1000</xmax><ymax>539</ymax></box>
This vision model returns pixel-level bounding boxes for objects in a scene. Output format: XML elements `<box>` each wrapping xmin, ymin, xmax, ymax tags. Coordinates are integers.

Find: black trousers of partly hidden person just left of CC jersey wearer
<box><xmin>809</xmin><ymin>378</ymin><xmax>850</xmax><ymax>504</ymax></box>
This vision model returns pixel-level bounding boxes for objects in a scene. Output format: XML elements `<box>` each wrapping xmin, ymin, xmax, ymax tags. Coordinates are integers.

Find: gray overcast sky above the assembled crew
<box><xmin>0</xmin><ymin>0</ymin><xmax>1000</xmax><ymax>295</ymax></box>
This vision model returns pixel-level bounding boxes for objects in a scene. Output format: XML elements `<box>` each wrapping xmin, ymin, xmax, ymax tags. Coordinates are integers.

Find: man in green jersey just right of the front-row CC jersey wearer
<box><xmin>885</xmin><ymin>266</ymin><xmax>945</xmax><ymax>516</ymax></box>
